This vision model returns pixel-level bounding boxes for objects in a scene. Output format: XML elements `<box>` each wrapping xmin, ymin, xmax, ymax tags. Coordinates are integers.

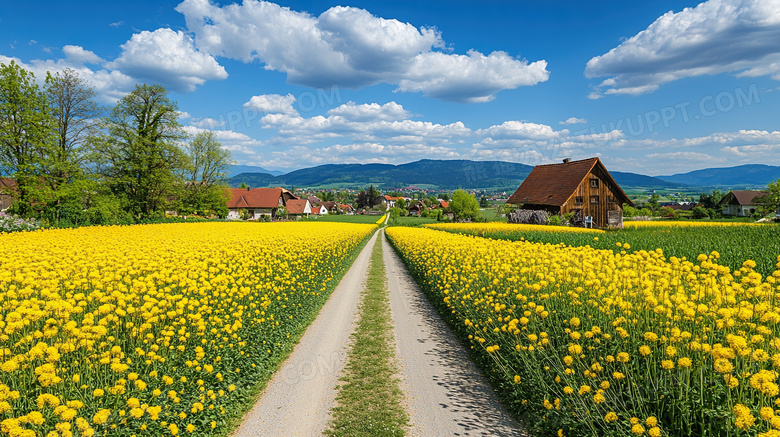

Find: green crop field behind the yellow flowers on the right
<box><xmin>430</xmin><ymin>224</ymin><xmax>780</xmax><ymax>275</ymax></box>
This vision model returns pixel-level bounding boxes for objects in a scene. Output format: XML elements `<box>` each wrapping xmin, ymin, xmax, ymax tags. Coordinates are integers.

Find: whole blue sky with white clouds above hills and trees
<box><xmin>0</xmin><ymin>0</ymin><xmax>780</xmax><ymax>175</ymax></box>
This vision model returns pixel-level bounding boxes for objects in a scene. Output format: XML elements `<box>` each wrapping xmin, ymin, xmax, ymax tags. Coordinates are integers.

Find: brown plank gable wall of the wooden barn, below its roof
<box><xmin>561</xmin><ymin>166</ymin><xmax>622</xmax><ymax>228</ymax></box>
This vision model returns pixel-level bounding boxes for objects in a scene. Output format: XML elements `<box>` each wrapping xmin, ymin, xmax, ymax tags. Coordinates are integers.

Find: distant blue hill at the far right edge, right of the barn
<box><xmin>656</xmin><ymin>164</ymin><xmax>780</xmax><ymax>188</ymax></box>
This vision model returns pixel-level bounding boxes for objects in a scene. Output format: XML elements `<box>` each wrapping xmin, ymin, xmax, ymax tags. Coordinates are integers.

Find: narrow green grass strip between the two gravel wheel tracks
<box><xmin>325</xmin><ymin>237</ymin><xmax>409</xmax><ymax>437</ymax></box>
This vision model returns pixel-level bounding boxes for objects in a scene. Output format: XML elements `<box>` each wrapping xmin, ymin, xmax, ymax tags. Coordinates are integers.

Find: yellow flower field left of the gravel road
<box><xmin>0</xmin><ymin>223</ymin><xmax>376</xmax><ymax>437</ymax></box>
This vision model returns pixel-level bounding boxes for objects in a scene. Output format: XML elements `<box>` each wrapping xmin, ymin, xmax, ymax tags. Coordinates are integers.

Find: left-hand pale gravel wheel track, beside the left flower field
<box><xmin>233</xmin><ymin>232</ymin><xmax>378</xmax><ymax>437</ymax></box>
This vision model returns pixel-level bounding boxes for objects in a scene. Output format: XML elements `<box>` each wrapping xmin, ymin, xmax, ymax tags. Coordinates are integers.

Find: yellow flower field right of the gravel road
<box><xmin>386</xmin><ymin>227</ymin><xmax>780</xmax><ymax>437</ymax></box>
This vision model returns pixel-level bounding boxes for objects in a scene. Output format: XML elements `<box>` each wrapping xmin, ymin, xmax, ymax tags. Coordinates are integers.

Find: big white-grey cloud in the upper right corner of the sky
<box><xmin>585</xmin><ymin>0</ymin><xmax>780</xmax><ymax>98</ymax></box>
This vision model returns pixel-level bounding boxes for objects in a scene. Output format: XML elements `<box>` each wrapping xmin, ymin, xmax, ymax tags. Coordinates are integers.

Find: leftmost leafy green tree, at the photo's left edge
<box><xmin>0</xmin><ymin>61</ymin><xmax>54</xmax><ymax>217</ymax></box>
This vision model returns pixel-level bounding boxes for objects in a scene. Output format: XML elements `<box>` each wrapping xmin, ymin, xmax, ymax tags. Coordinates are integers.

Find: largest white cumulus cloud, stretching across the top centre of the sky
<box><xmin>176</xmin><ymin>0</ymin><xmax>549</xmax><ymax>102</ymax></box>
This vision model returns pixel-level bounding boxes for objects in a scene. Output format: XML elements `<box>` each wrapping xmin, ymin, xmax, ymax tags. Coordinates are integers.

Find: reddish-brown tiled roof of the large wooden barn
<box><xmin>507</xmin><ymin>158</ymin><xmax>631</xmax><ymax>206</ymax></box>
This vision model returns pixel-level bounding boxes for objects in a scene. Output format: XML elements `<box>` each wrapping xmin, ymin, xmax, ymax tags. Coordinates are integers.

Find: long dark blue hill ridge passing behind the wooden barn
<box><xmin>230</xmin><ymin>159</ymin><xmax>679</xmax><ymax>190</ymax></box>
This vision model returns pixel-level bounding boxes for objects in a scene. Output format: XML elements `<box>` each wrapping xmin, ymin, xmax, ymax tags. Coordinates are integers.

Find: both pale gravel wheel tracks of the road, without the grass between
<box><xmin>233</xmin><ymin>231</ymin><xmax>525</xmax><ymax>437</ymax></box>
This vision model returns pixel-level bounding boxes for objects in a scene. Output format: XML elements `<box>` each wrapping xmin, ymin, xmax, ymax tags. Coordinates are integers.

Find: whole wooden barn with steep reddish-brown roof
<box><xmin>507</xmin><ymin>158</ymin><xmax>633</xmax><ymax>228</ymax></box>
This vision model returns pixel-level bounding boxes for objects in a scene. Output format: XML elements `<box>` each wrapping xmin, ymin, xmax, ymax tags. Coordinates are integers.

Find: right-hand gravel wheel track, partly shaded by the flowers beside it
<box><xmin>382</xmin><ymin>231</ymin><xmax>526</xmax><ymax>437</ymax></box>
